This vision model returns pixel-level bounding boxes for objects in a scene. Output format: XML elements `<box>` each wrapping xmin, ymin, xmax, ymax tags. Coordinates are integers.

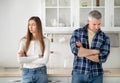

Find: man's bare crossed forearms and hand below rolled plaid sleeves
<box><xmin>76</xmin><ymin>42</ymin><xmax>99</xmax><ymax>62</ymax></box>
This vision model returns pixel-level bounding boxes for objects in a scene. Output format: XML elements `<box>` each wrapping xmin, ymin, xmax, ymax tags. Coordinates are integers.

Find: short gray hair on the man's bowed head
<box><xmin>88</xmin><ymin>10</ymin><xmax>102</xmax><ymax>20</ymax></box>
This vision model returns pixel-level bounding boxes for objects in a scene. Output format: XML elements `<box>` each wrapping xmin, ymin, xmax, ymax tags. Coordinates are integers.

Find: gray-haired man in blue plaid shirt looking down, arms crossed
<box><xmin>70</xmin><ymin>10</ymin><xmax>110</xmax><ymax>83</ymax></box>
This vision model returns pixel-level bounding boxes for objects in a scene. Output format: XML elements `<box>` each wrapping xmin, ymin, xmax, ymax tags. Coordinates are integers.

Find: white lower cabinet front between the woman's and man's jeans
<box><xmin>48</xmin><ymin>76</ymin><xmax>69</xmax><ymax>83</ymax></box>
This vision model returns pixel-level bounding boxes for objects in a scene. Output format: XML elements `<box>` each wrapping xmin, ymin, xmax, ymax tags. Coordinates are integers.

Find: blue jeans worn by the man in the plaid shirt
<box><xmin>72</xmin><ymin>71</ymin><xmax>103</xmax><ymax>83</ymax></box>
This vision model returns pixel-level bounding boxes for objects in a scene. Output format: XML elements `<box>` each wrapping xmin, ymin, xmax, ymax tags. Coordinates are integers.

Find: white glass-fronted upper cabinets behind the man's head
<box><xmin>41</xmin><ymin>0</ymin><xmax>120</xmax><ymax>33</ymax></box>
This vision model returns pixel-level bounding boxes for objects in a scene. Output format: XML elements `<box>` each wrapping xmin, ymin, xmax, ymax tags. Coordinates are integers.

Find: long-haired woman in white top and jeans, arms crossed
<box><xmin>18</xmin><ymin>16</ymin><xmax>50</xmax><ymax>83</ymax></box>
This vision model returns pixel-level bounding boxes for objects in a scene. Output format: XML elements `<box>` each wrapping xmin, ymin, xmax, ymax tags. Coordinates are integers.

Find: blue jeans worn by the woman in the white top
<box><xmin>22</xmin><ymin>66</ymin><xmax>48</xmax><ymax>83</ymax></box>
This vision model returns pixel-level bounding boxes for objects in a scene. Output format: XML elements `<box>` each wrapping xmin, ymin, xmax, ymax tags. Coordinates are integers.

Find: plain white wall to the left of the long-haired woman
<box><xmin>0</xmin><ymin>0</ymin><xmax>41</xmax><ymax>67</ymax></box>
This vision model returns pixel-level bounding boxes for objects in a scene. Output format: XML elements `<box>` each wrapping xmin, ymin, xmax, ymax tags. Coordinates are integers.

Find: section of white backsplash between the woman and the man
<box><xmin>47</xmin><ymin>35</ymin><xmax>73</xmax><ymax>68</ymax></box>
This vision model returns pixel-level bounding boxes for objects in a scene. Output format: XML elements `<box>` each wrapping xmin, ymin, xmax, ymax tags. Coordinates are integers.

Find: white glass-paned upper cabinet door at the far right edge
<box><xmin>105</xmin><ymin>0</ymin><xmax>120</xmax><ymax>31</ymax></box>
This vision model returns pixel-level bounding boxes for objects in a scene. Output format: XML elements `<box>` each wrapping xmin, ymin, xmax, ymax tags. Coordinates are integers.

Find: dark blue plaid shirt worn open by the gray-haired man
<box><xmin>70</xmin><ymin>25</ymin><xmax>110</xmax><ymax>76</ymax></box>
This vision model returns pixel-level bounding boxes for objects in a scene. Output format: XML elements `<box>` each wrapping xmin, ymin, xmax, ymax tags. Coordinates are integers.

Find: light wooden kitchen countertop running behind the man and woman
<box><xmin>0</xmin><ymin>68</ymin><xmax>120</xmax><ymax>77</ymax></box>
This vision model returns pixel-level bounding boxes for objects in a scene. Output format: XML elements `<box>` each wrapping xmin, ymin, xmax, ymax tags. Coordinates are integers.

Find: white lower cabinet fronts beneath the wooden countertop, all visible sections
<box><xmin>0</xmin><ymin>76</ymin><xmax>120</xmax><ymax>83</ymax></box>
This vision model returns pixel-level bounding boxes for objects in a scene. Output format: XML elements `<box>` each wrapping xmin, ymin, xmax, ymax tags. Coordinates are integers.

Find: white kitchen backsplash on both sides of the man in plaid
<box><xmin>47</xmin><ymin>34</ymin><xmax>120</xmax><ymax>68</ymax></box>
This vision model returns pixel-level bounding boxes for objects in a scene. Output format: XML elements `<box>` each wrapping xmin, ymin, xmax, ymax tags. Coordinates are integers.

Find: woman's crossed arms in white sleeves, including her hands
<box><xmin>17</xmin><ymin>39</ymin><xmax>50</xmax><ymax>64</ymax></box>
